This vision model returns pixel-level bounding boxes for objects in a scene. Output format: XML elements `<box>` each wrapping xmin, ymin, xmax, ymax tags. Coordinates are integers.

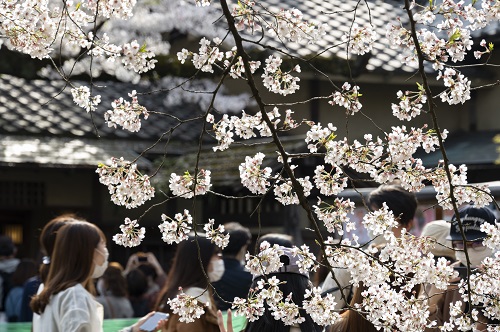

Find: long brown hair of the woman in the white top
<box><xmin>30</xmin><ymin>221</ymin><xmax>105</xmax><ymax>314</ymax></box>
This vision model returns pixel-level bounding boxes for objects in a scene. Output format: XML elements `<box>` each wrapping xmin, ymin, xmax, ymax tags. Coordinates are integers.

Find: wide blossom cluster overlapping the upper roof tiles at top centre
<box><xmin>268</xmin><ymin>8</ymin><xmax>326</xmax><ymax>43</ymax></box>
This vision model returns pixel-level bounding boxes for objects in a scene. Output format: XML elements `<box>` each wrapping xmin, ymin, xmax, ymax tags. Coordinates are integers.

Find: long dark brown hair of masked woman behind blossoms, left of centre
<box><xmin>155</xmin><ymin>236</ymin><xmax>217</xmax><ymax>312</ymax></box>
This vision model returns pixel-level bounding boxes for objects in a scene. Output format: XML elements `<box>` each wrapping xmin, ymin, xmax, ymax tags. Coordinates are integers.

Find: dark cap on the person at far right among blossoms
<box><xmin>447</xmin><ymin>205</ymin><xmax>496</xmax><ymax>241</ymax></box>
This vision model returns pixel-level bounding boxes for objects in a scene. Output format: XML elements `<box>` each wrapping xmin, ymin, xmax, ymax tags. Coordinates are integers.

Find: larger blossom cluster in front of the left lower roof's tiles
<box><xmin>104</xmin><ymin>90</ymin><xmax>149</xmax><ymax>132</ymax></box>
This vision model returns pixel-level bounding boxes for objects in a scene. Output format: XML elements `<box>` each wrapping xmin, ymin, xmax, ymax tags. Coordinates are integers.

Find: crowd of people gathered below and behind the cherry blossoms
<box><xmin>0</xmin><ymin>185</ymin><xmax>496</xmax><ymax>332</ymax></box>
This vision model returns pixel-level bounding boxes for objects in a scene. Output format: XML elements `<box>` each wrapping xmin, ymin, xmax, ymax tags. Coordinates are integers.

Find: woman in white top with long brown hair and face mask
<box><xmin>31</xmin><ymin>220</ymin><xmax>154</xmax><ymax>332</ymax></box>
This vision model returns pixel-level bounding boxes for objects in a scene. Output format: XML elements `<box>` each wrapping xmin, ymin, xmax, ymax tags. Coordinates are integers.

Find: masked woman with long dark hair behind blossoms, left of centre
<box><xmin>156</xmin><ymin>236</ymin><xmax>224</xmax><ymax>332</ymax></box>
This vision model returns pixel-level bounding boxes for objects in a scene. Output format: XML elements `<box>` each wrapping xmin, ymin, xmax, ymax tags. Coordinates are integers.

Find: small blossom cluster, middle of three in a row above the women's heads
<box><xmin>158</xmin><ymin>210</ymin><xmax>193</xmax><ymax>244</ymax></box>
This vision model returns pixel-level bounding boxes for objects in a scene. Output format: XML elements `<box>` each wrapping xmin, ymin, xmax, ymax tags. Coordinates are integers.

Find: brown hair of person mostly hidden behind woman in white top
<box><xmin>38</xmin><ymin>214</ymin><xmax>81</xmax><ymax>283</ymax></box>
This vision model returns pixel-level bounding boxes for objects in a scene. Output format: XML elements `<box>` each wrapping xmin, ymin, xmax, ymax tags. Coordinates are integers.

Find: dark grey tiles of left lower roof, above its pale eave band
<box><xmin>0</xmin><ymin>75</ymin><xmax>205</xmax><ymax>140</ymax></box>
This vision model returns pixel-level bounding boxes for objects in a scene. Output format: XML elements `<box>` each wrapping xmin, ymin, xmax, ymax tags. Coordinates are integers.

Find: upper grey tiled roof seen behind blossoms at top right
<box><xmin>254</xmin><ymin>0</ymin><xmax>415</xmax><ymax>72</ymax></box>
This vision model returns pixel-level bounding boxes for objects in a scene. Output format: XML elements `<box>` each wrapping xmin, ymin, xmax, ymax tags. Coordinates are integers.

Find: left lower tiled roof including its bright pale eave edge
<box><xmin>0</xmin><ymin>75</ymin><xmax>202</xmax><ymax>167</ymax></box>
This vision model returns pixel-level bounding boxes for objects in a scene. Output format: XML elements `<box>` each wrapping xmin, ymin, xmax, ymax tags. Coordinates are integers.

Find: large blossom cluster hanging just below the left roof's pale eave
<box><xmin>96</xmin><ymin>157</ymin><xmax>155</xmax><ymax>209</ymax></box>
